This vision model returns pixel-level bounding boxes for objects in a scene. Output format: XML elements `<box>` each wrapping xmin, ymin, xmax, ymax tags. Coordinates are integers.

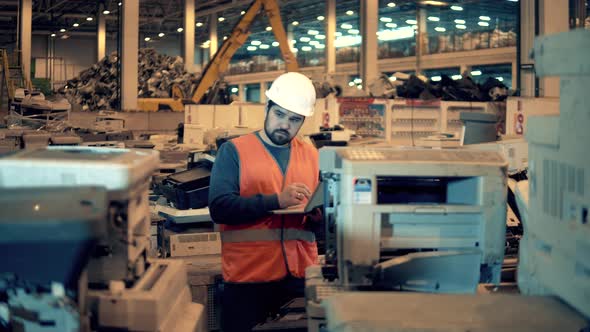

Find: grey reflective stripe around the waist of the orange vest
<box><xmin>221</xmin><ymin>228</ymin><xmax>315</xmax><ymax>243</ymax></box>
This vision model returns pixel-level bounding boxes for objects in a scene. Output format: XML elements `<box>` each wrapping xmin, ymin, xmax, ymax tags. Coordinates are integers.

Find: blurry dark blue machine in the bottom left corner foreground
<box><xmin>0</xmin><ymin>187</ymin><xmax>107</xmax><ymax>332</ymax></box>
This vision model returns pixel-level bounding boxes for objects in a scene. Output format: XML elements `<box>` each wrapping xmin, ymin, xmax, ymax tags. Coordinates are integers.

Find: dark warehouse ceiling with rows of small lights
<box><xmin>0</xmin><ymin>0</ymin><xmax>590</xmax><ymax>55</ymax></box>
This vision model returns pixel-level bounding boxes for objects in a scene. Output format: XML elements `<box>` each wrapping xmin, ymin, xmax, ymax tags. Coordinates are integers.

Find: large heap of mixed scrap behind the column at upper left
<box><xmin>60</xmin><ymin>48</ymin><xmax>200</xmax><ymax>111</ymax></box>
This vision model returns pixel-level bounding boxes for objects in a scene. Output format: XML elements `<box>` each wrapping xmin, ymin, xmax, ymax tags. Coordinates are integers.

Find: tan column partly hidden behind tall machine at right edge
<box><xmin>538</xmin><ymin>0</ymin><xmax>569</xmax><ymax>97</ymax></box>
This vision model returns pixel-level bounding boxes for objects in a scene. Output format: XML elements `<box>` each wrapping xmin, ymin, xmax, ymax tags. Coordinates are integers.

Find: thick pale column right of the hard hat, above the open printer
<box><xmin>360</xmin><ymin>0</ymin><xmax>379</xmax><ymax>94</ymax></box>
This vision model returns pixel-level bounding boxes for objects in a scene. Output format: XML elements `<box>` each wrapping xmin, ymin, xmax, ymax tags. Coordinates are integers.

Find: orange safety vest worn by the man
<box><xmin>220</xmin><ymin>134</ymin><xmax>319</xmax><ymax>282</ymax></box>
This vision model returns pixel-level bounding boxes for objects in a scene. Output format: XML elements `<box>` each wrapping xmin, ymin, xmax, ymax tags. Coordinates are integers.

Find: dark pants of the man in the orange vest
<box><xmin>221</xmin><ymin>276</ymin><xmax>305</xmax><ymax>332</ymax></box>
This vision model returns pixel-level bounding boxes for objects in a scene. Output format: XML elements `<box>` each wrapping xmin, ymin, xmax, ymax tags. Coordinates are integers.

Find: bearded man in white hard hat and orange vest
<box><xmin>209</xmin><ymin>73</ymin><xmax>319</xmax><ymax>331</ymax></box>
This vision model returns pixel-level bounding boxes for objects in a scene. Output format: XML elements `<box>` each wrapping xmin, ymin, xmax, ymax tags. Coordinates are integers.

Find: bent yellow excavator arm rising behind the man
<box><xmin>191</xmin><ymin>0</ymin><xmax>299</xmax><ymax>103</ymax></box>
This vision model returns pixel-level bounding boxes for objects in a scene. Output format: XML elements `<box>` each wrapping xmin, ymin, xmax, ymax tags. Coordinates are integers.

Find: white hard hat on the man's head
<box><xmin>265</xmin><ymin>72</ymin><xmax>315</xmax><ymax>116</ymax></box>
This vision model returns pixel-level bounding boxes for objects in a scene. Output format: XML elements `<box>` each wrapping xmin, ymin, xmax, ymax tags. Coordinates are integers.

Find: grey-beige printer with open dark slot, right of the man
<box><xmin>320</xmin><ymin>148</ymin><xmax>507</xmax><ymax>293</ymax></box>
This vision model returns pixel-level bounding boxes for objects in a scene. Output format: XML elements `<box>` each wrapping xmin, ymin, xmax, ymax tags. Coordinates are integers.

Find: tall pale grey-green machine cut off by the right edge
<box><xmin>517</xmin><ymin>30</ymin><xmax>590</xmax><ymax>319</ymax></box>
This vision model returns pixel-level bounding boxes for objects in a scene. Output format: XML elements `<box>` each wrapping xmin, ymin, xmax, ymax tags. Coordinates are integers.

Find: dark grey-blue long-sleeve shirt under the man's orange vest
<box><xmin>209</xmin><ymin>133</ymin><xmax>291</xmax><ymax>225</ymax></box>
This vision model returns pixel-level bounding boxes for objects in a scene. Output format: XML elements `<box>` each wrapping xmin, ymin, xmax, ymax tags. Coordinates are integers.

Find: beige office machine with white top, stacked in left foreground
<box><xmin>0</xmin><ymin>146</ymin><xmax>203</xmax><ymax>331</ymax></box>
